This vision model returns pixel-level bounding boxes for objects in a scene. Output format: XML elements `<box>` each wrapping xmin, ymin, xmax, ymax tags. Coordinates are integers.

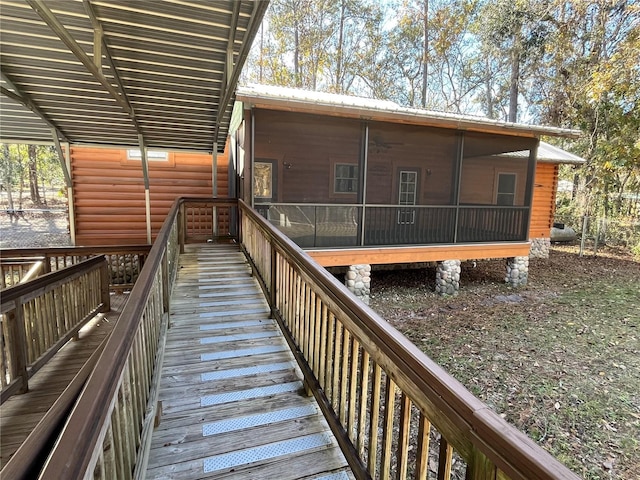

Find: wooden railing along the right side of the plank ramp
<box><xmin>239</xmin><ymin>202</ymin><xmax>579</xmax><ymax>480</ymax></box>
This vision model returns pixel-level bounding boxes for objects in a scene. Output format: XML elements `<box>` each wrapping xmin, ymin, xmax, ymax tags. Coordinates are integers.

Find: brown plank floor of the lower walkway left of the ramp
<box><xmin>0</xmin><ymin>295</ymin><xmax>128</xmax><ymax>468</ymax></box>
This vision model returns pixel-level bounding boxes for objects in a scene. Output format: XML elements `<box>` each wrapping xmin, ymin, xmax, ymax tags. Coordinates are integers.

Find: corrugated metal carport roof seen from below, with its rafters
<box><xmin>0</xmin><ymin>0</ymin><xmax>268</xmax><ymax>151</ymax></box>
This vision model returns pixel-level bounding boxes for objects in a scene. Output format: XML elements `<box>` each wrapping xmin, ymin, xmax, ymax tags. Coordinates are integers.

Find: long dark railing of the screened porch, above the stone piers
<box><xmin>255</xmin><ymin>203</ymin><xmax>529</xmax><ymax>248</ymax></box>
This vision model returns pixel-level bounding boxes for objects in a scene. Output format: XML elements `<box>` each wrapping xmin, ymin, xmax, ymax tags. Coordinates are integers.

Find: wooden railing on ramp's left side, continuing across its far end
<box><xmin>31</xmin><ymin>198</ymin><xmax>237</xmax><ymax>480</ymax></box>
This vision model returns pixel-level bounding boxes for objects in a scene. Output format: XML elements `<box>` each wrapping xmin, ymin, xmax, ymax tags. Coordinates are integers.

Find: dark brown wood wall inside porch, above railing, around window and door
<box><xmin>254</xmin><ymin>110</ymin><xmax>457</xmax><ymax>205</ymax></box>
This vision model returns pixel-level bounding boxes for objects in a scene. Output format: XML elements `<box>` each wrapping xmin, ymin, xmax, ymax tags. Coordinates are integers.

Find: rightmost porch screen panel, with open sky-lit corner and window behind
<box><xmin>457</xmin><ymin>133</ymin><xmax>536</xmax><ymax>243</ymax></box>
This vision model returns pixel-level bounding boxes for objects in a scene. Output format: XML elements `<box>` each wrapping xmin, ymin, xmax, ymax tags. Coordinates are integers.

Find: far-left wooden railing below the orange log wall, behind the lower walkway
<box><xmin>0</xmin><ymin>245</ymin><xmax>151</xmax><ymax>289</ymax></box>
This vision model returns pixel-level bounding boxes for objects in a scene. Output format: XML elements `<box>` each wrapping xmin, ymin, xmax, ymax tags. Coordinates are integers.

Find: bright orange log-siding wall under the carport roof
<box><xmin>71</xmin><ymin>146</ymin><xmax>229</xmax><ymax>245</ymax></box>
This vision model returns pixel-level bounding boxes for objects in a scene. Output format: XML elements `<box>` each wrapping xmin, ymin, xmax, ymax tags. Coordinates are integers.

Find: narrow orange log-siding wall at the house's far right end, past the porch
<box><xmin>529</xmin><ymin>163</ymin><xmax>558</xmax><ymax>238</ymax></box>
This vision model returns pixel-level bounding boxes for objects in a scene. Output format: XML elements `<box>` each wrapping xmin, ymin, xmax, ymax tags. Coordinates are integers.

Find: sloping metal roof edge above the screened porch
<box><xmin>237</xmin><ymin>85</ymin><xmax>581</xmax><ymax>138</ymax></box>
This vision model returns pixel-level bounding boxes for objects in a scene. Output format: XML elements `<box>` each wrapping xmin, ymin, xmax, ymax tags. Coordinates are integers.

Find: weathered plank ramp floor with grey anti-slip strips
<box><xmin>147</xmin><ymin>244</ymin><xmax>353</xmax><ymax>480</ymax></box>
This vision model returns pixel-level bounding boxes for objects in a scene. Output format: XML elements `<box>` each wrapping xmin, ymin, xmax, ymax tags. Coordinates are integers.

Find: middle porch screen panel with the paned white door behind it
<box><xmin>364</xmin><ymin>122</ymin><xmax>458</xmax><ymax>245</ymax></box>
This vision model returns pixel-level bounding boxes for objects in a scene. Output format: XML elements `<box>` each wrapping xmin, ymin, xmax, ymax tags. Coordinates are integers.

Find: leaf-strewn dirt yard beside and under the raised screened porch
<box><xmin>371</xmin><ymin>246</ymin><xmax>640</xmax><ymax>480</ymax></box>
